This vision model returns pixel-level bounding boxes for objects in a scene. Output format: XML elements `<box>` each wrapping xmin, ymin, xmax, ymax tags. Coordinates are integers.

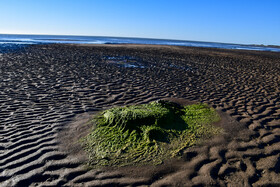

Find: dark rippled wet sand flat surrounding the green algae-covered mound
<box><xmin>0</xmin><ymin>44</ymin><xmax>280</xmax><ymax>186</ymax></box>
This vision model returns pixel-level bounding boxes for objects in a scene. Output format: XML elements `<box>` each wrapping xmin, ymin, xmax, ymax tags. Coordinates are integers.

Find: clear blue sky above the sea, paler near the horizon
<box><xmin>0</xmin><ymin>0</ymin><xmax>280</xmax><ymax>45</ymax></box>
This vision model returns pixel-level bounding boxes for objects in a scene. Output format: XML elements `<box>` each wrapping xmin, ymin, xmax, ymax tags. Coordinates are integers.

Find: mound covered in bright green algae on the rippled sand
<box><xmin>82</xmin><ymin>100</ymin><xmax>220</xmax><ymax>166</ymax></box>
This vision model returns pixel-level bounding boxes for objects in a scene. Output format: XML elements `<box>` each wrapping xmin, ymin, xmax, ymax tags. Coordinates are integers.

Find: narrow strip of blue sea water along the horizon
<box><xmin>0</xmin><ymin>34</ymin><xmax>280</xmax><ymax>53</ymax></box>
